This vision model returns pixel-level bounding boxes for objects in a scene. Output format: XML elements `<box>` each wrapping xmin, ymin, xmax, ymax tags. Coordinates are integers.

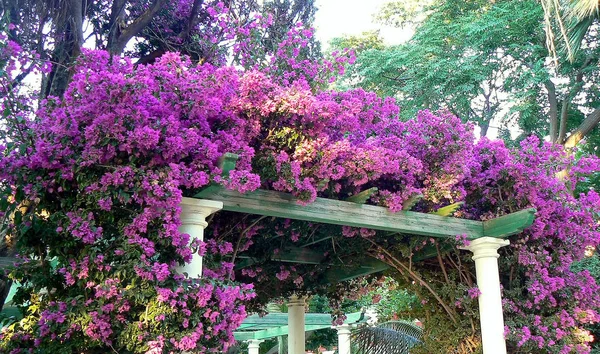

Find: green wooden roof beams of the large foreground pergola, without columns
<box><xmin>194</xmin><ymin>153</ymin><xmax>536</xmax><ymax>283</ymax></box>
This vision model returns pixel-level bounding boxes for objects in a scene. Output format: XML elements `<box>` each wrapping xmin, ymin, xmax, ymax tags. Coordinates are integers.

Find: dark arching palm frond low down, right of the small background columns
<box><xmin>352</xmin><ymin>321</ymin><xmax>423</xmax><ymax>354</ymax></box>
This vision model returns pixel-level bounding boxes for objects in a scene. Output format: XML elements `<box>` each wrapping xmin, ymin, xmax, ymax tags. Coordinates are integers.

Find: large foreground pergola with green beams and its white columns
<box><xmin>181</xmin><ymin>154</ymin><xmax>536</xmax><ymax>354</ymax></box>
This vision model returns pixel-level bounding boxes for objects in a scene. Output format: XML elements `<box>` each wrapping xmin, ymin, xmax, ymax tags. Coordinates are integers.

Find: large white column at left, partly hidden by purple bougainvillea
<box><xmin>177</xmin><ymin>198</ymin><xmax>223</xmax><ymax>278</ymax></box>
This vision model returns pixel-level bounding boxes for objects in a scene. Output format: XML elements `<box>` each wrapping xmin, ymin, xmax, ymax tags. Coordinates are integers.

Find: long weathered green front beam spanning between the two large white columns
<box><xmin>195</xmin><ymin>186</ymin><xmax>483</xmax><ymax>238</ymax></box>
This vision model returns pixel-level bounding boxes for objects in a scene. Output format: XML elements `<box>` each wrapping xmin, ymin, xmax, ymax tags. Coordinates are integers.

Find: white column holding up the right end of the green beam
<box><xmin>464</xmin><ymin>237</ymin><xmax>510</xmax><ymax>354</ymax></box>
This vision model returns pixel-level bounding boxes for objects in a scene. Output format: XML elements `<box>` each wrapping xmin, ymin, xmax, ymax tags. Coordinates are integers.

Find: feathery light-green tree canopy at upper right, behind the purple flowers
<box><xmin>338</xmin><ymin>0</ymin><xmax>600</xmax><ymax>146</ymax></box>
